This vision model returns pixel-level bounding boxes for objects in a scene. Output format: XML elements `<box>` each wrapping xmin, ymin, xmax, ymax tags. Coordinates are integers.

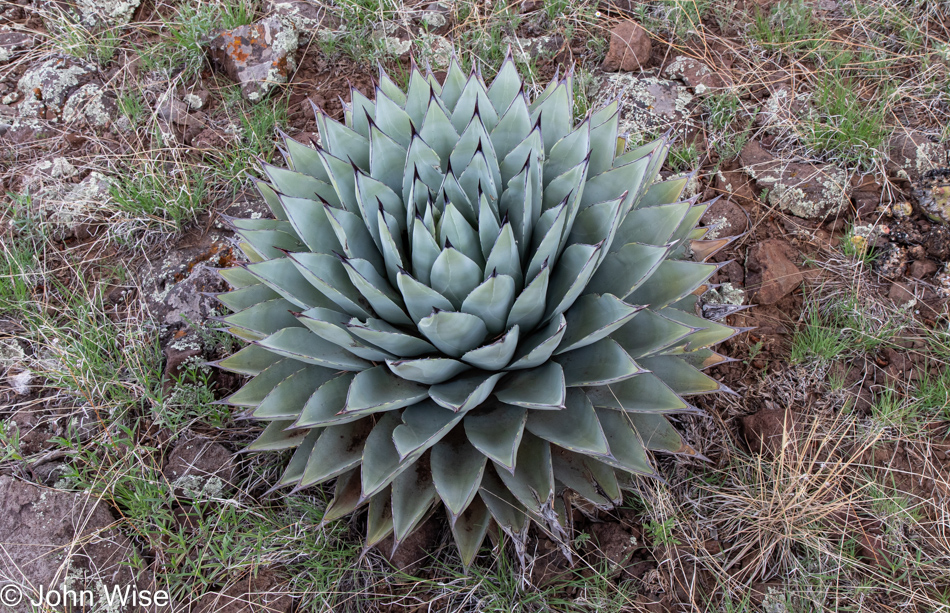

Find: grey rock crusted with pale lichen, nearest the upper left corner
<box><xmin>17</xmin><ymin>58</ymin><xmax>95</xmax><ymax>119</ymax></box>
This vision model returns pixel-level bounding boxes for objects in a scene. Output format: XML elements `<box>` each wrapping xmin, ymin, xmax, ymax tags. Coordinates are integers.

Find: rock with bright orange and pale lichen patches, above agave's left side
<box><xmin>210</xmin><ymin>17</ymin><xmax>298</xmax><ymax>102</ymax></box>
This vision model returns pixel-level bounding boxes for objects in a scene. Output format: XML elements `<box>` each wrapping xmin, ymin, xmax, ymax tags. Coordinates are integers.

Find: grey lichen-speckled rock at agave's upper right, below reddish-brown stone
<box><xmin>597</xmin><ymin>73</ymin><xmax>693</xmax><ymax>135</ymax></box>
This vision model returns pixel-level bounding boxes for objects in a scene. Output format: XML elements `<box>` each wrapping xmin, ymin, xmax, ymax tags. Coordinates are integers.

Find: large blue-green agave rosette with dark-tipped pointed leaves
<box><xmin>212</xmin><ymin>56</ymin><xmax>736</xmax><ymax>565</ymax></box>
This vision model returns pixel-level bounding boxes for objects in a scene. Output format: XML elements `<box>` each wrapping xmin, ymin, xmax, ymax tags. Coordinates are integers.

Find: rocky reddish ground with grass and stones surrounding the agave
<box><xmin>0</xmin><ymin>0</ymin><xmax>950</xmax><ymax>612</ymax></box>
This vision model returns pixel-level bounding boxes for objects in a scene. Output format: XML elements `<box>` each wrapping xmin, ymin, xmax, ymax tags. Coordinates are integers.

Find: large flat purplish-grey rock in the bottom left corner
<box><xmin>0</xmin><ymin>476</ymin><xmax>155</xmax><ymax>613</ymax></box>
